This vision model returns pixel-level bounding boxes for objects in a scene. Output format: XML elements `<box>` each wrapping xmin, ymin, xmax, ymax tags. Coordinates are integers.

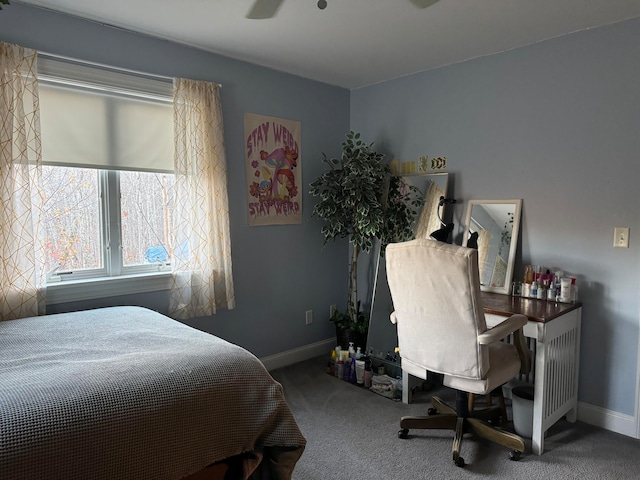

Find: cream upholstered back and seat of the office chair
<box><xmin>385</xmin><ymin>238</ymin><xmax>527</xmax><ymax>394</ymax></box>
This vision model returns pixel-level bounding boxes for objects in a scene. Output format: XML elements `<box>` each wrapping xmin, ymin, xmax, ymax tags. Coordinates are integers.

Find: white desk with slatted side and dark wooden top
<box><xmin>402</xmin><ymin>292</ymin><xmax>582</xmax><ymax>455</ymax></box>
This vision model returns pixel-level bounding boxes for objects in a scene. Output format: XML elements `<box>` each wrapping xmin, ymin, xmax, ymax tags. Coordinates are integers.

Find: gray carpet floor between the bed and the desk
<box><xmin>271</xmin><ymin>358</ymin><xmax>640</xmax><ymax>480</ymax></box>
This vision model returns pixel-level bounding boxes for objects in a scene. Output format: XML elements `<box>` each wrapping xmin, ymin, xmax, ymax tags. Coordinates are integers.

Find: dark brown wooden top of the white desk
<box><xmin>481</xmin><ymin>292</ymin><xmax>582</xmax><ymax>323</ymax></box>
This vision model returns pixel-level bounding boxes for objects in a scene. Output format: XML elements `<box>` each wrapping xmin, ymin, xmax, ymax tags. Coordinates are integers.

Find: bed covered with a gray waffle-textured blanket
<box><xmin>0</xmin><ymin>307</ymin><xmax>306</xmax><ymax>480</ymax></box>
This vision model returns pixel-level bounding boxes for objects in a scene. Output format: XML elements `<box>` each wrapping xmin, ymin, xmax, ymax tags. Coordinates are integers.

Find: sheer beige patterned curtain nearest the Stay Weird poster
<box><xmin>169</xmin><ymin>78</ymin><xmax>235</xmax><ymax>320</ymax></box>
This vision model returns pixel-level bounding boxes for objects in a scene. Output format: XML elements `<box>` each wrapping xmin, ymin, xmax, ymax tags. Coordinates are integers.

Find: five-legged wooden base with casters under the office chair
<box><xmin>398</xmin><ymin>397</ymin><xmax>524</xmax><ymax>467</ymax></box>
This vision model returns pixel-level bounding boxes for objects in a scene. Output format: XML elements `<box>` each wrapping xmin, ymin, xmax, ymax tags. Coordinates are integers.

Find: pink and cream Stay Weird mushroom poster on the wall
<box><xmin>244</xmin><ymin>113</ymin><xmax>302</xmax><ymax>226</ymax></box>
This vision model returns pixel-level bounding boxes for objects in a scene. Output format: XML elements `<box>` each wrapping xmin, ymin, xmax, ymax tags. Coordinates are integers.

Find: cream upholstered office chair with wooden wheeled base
<box><xmin>385</xmin><ymin>239</ymin><xmax>531</xmax><ymax>467</ymax></box>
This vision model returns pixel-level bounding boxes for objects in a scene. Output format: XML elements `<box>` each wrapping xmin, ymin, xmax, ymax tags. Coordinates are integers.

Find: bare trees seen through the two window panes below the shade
<box><xmin>43</xmin><ymin>165</ymin><xmax>174</xmax><ymax>273</ymax></box>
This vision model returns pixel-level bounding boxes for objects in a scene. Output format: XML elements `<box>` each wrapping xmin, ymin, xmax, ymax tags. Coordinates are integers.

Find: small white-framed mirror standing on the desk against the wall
<box><xmin>463</xmin><ymin>199</ymin><xmax>522</xmax><ymax>294</ymax></box>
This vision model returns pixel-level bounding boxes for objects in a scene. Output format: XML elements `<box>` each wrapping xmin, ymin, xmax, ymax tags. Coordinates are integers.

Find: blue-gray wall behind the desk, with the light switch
<box><xmin>351</xmin><ymin>19</ymin><xmax>640</xmax><ymax>415</ymax></box>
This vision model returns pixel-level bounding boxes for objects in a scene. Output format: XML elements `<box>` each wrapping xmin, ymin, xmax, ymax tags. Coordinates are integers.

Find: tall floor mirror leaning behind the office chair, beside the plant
<box><xmin>367</xmin><ymin>173</ymin><xmax>449</xmax><ymax>366</ymax></box>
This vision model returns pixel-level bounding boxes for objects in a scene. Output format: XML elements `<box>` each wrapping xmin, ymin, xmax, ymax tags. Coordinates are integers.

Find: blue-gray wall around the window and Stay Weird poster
<box><xmin>0</xmin><ymin>3</ymin><xmax>349</xmax><ymax>357</ymax></box>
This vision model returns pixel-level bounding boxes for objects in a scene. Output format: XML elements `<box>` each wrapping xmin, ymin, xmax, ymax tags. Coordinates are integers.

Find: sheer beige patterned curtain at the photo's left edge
<box><xmin>0</xmin><ymin>42</ymin><xmax>45</xmax><ymax>320</ymax></box>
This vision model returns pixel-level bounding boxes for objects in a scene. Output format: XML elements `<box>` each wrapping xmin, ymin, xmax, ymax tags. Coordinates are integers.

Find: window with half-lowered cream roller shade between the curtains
<box><xmin>38</xmin><ymin>57</ymin><xmax>179</xmax><ymax>293</ymax></box>
